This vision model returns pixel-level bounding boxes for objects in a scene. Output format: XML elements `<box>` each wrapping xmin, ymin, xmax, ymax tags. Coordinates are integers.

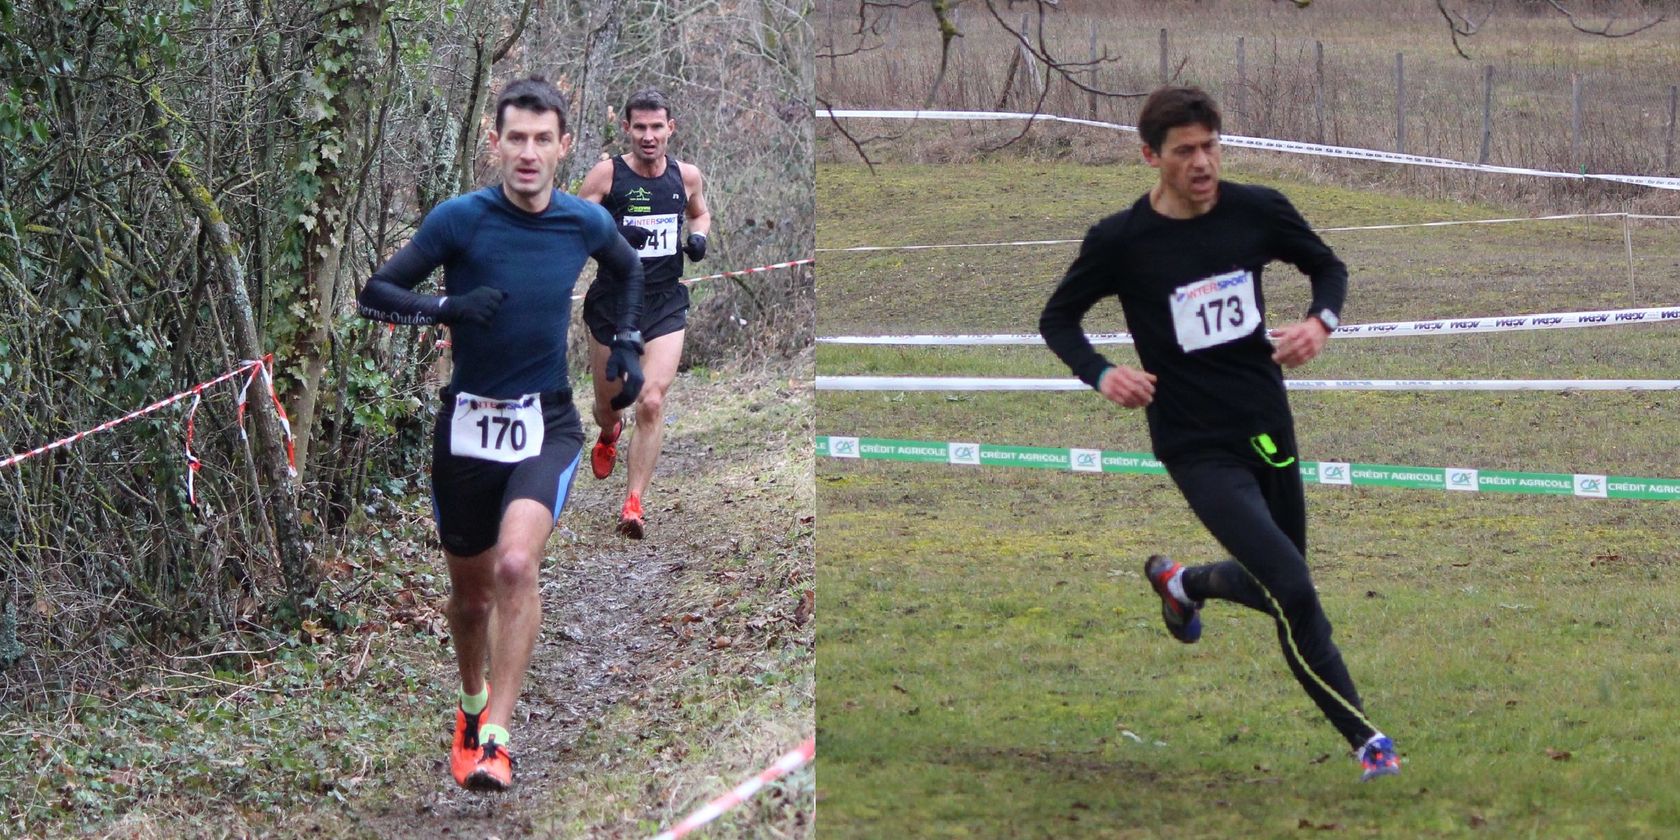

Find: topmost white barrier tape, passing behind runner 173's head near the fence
<box><xmin>816</xmin><ymin>109</ymin><xmax>1680</xmax><ymax>190</ymax></box>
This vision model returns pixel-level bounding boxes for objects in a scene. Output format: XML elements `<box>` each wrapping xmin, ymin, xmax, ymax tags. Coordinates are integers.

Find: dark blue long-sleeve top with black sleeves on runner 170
<box><xmin>358</xmin><ymin>185</ymin><xmax>642</xmax><ymax>400</ymax></box>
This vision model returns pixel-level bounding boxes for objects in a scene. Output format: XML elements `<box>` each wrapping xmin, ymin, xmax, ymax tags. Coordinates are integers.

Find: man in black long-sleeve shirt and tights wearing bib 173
<box><xmin>1038</xmin><ymin>87</ymin><xmax>1399</xmax><ymax>778</ymax></box>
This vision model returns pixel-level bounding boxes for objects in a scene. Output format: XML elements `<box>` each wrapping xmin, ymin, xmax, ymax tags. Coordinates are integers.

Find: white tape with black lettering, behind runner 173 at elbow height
<box><xmin>816</xmin><ymin>306</ymin><xmax>1680</xmax><ymax>348</ymax></box>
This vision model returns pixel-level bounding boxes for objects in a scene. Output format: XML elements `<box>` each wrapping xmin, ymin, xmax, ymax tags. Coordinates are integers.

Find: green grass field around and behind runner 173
<box><xmin>816</xmin><ymin>156</ymin><xmax>1680</xmax><ymax>837</ymax></box>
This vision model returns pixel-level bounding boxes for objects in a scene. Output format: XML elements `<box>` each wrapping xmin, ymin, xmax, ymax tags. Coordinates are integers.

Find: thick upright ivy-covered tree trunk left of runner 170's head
<box><xmin>287</xmin><ymin>0</ymin><xmax>386</xmax><ymax>474</ymax></box>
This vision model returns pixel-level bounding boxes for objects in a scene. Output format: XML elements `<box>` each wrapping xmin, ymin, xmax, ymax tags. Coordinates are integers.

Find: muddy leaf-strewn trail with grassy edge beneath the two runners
<box><xmin>323</xmin><ymin>363</ymin><xmax>815</xmax><ymax>838</ymax></box>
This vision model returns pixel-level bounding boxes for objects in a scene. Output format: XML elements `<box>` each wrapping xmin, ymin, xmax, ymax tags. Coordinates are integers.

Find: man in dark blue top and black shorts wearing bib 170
<box><xmin>360</xmin><ymin>77</ymin><xmax>642</xmax><ymax>790</ymax></box>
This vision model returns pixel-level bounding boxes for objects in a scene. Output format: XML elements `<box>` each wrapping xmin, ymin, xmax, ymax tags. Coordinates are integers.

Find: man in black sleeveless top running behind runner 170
<box><xmin>578</xmin><ymin>89</ymin><xmax>712</xmax><ymax>539</ymax></box>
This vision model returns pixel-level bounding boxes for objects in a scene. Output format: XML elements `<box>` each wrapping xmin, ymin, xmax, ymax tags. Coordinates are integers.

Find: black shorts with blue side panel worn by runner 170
<box><xmin>432</xmin><ymin>388</ymin><xmax>583</xmax><ymax>558</ymax></box>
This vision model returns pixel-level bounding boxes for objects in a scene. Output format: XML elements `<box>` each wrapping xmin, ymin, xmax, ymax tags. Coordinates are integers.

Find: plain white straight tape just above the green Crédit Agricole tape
<box><xmin>816</xmin><ymin>376</ymin><xmax>1680</xmax><ymax>391</ymax></box>
